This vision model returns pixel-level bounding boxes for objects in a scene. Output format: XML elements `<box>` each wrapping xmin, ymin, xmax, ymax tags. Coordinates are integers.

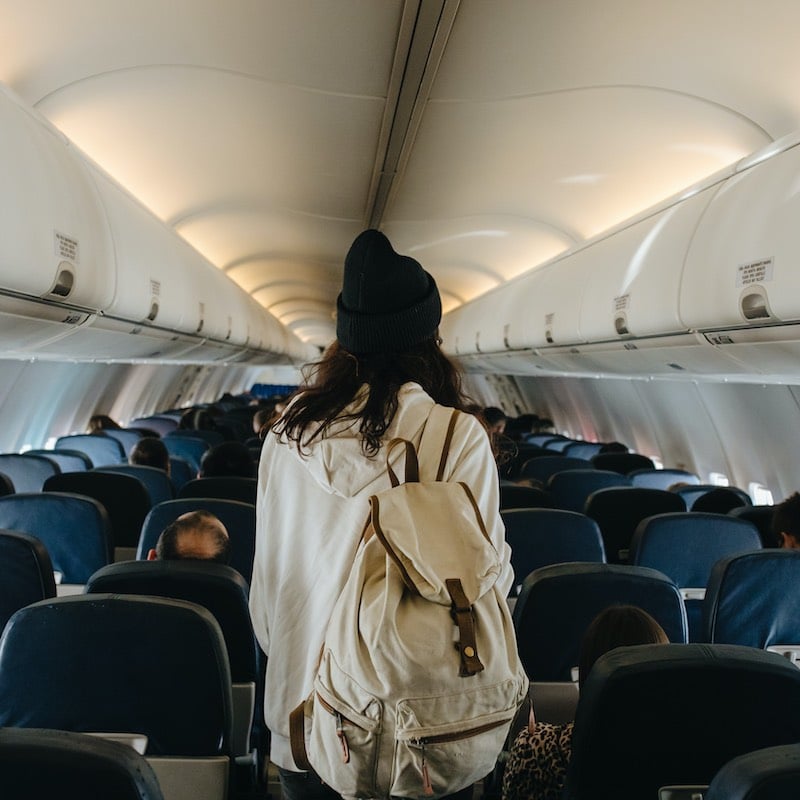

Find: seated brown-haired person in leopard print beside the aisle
<box><xmin>503</xmin><ymin>606</ymin><xmax>669</xmax><ymax>800</ymax></box>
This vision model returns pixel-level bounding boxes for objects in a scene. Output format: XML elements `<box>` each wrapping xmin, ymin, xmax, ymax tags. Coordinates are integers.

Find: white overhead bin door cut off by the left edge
<box><xmin>0</xmin><ymin>86</ymin><xmax>114</xmax><ymax>310</ymax></box>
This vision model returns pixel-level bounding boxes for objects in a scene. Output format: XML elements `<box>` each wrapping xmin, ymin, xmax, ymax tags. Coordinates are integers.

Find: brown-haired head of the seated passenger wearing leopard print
<box><xmin>578</xmin><ymin>606</ymin><xmax>669</xmax><ymax>686</ymax></box>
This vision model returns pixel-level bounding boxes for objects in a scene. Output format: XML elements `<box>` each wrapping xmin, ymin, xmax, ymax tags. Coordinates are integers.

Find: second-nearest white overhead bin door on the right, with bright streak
<box><xmin>574</xmin><ymin>187</ymin><xmax>716</xmax><ymax>342</ymax></box>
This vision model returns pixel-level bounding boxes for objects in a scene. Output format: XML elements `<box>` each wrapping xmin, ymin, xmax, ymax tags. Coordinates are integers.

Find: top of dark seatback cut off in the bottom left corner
<box><xmin>0</xmin><ymin>728</ymin><xmax>163</xmax><ymax>800</ymax></box>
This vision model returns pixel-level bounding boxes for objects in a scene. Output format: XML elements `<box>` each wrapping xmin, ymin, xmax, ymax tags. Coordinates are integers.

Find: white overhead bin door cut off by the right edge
<box><xmin>680</xmin><ymin>147</ymin><xmax>800</xmax><ymax>330</ymax></box>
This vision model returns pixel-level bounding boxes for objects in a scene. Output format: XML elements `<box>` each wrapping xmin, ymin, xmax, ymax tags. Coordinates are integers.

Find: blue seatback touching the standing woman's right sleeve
<box><xmin>500</xmin><ymin>508</ymin><xmax>605</xmax><ymax>587</ymax></box>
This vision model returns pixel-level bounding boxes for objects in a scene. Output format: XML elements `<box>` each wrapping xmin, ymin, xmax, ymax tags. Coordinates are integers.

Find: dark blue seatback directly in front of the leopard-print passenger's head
<box><xmin>514</xmin><ymin>564</ymin><xmax>687</xmax><ymax>681</ymax></box>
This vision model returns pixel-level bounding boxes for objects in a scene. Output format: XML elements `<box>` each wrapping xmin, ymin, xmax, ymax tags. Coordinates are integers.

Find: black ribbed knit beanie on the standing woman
<box><xmin>336</xmin><ymin>230</ymin><xmax>442</xmax><ymax>355</ymax></box>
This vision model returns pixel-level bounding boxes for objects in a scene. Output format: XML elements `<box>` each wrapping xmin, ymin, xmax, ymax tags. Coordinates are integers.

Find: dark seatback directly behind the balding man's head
<box><xmin>86</xmin><ymin>561</ymin><xmax>253</xmax><ymax>683</ymax></box>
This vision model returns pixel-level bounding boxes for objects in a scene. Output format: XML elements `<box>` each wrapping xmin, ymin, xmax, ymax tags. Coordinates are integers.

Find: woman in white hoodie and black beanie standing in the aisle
<box><xmin>250</xmin><ymin>230</ymin><xmax>506</xmax><ymax>800</ymax></box>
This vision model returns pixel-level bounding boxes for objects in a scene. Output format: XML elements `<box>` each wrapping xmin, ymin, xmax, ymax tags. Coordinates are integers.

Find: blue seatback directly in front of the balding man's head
<box><xmin>136</xmin><ymin>497</ymin><xmax>256</xmax><ymax>583</ymax></box>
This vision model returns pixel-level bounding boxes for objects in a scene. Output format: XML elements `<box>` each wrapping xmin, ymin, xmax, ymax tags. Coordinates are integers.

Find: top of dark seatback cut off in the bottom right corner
<box><xmin>705</xmin><ymin>744</ymin><xmax>800</xmax><ymax>800</ymax></box>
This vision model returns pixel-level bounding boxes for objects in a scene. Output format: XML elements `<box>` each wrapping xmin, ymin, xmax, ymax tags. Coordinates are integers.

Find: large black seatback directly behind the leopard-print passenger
<box><xmin>564</xmin><ymin>644</ymin><xmax>800</xmax><ymax>800</ymax></box>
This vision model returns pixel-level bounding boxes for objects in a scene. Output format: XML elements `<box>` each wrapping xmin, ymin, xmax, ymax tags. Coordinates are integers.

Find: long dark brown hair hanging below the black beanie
<box><xmin>272</xmin><ymin>339</ymin><xmax>476</xmax><ymax>457</ymax></box>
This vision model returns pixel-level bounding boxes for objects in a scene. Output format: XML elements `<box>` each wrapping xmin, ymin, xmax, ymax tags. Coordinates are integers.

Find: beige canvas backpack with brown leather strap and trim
<box><xmin>291</xmin><ymin>406</ymin><xmax>528</xmax><ymax>798</ymax></box>
